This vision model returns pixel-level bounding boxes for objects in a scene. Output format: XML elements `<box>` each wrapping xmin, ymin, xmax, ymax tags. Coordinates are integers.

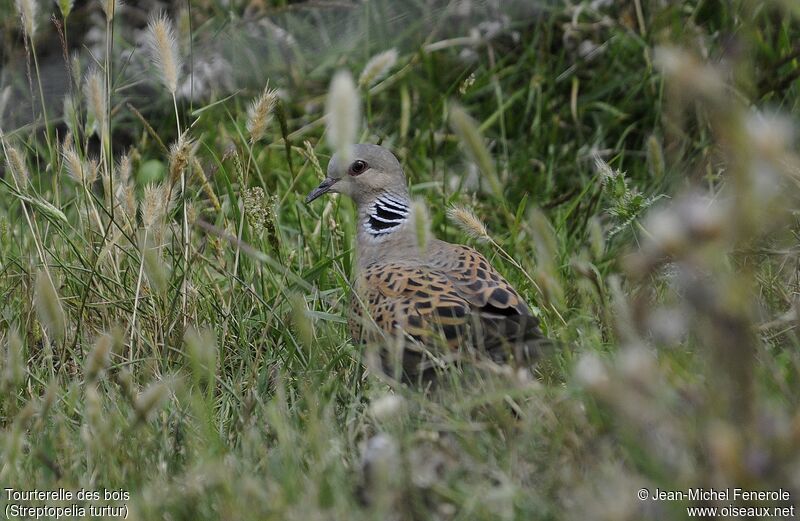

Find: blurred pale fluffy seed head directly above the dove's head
<box><xmin>326</xmin><ymin>71</ymin><xmax>361</xmax><ymax>164</ymax></box>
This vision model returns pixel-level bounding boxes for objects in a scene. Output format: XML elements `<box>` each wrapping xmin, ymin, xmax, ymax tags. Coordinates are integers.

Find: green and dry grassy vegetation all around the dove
<box><xmin>0</xmin><ymin>0</ymin><xmax>800</xmax><ymax>520</ymax></box>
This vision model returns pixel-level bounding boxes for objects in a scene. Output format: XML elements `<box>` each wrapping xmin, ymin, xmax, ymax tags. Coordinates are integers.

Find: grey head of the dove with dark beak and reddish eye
<box><xmin>306</xmin><ymin>144</ymin><xmax>408</xmax><ymax>204</ymax></box>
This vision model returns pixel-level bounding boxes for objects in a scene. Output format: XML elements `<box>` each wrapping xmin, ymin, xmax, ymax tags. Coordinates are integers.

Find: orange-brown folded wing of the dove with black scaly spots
<box><xmin>351</xmin><ymin>247</ymin><xmax>542</xmax><ymax>360</ymax></box>
